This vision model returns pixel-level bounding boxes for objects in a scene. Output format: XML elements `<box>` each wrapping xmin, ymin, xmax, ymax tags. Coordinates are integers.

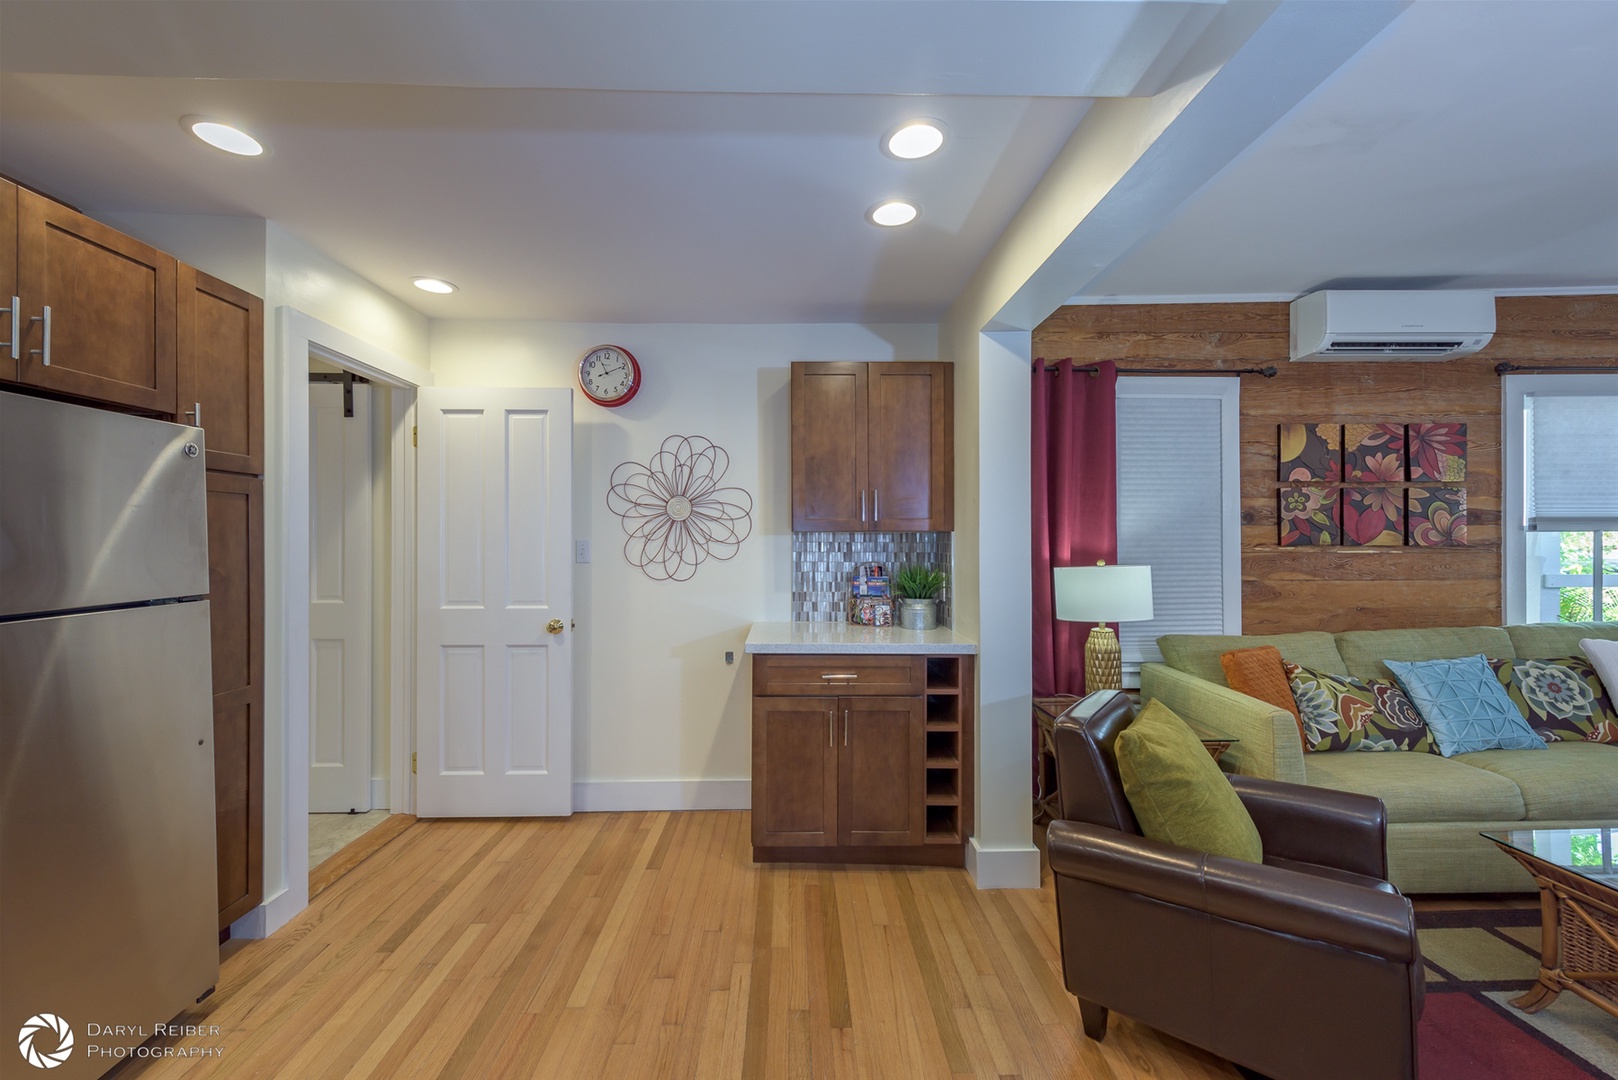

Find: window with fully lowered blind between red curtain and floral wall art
<box><xmin>1118</xmin><ymin>376</ymin><xmax>1241</xmax><ymax>685</ymax></box>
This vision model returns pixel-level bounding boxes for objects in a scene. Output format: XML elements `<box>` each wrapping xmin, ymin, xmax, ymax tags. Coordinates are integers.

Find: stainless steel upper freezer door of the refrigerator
<box><xmin>0</xmin><ymin>393</ymin><xmax>207</xmax><ymax>619</ymax></box>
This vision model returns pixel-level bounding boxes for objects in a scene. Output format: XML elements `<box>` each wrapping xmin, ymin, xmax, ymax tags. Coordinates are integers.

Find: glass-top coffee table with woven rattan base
<box><xmin>1484</xmin><ymin>826</ymin><xmax>1618</xmax><ymax>1017</ymax></box>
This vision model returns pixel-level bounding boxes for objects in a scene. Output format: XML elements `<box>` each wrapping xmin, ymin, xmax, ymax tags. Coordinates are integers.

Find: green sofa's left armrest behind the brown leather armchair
<box><xmin>1141</xmin><ymin>662</ymin><xmax>1304</xmax><ymax>784</ymax></box>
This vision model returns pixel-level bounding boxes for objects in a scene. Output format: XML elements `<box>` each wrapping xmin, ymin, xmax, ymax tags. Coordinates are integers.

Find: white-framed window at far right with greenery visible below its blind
<box><xmin>1502</xmin><ymin>376</ymin><xmax>1618</xmax><ymax>622</ymax></box>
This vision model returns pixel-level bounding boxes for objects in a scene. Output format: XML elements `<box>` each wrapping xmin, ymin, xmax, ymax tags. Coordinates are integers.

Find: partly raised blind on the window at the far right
<box><xmin>1523</xmin><ymin>395</ymin><xmax>1618</xmax><ymax>533</ymax></box>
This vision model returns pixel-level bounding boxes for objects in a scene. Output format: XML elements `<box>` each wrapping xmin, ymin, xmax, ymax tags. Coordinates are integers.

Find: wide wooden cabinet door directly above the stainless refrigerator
<box><xmin>16</xmin><ymin>189</ymin><xmax>176</xmax><ymax>415</ymax></box>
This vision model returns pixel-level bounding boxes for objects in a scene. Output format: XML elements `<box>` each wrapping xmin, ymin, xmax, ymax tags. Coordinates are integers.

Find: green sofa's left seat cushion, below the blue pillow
<box><xmin>1304</xmin><ymin>746</ymin><xmax>1520</xmax><ymax>823</ymax></box>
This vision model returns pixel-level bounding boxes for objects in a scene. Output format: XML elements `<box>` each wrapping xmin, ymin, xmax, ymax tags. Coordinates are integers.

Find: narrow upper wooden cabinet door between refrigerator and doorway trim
<box><xmin>175</xmin><ymin>264</ymin><xmax>264</xmax><ymax>474</ymax></box>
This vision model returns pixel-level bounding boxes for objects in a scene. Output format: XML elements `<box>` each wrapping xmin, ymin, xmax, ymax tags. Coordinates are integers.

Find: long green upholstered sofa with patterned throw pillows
<box><xmin>1141</xmin><ymin>623</ymin><xmax>1618</xmax><ymax>892</ymax></box>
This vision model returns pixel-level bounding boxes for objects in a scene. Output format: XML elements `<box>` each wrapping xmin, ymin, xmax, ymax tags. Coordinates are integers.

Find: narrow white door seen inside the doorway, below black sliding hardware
<box><xmin>309</xmin><ymin>382</ymin><xmax>372</xmax><ymax>813</ymax></box>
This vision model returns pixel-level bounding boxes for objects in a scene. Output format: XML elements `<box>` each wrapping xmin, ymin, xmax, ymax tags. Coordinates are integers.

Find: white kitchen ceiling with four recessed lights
<box><xmin>0</xmin><ymin>0</ymin><xmax>1236</xmax><ymax>322</ymax></box>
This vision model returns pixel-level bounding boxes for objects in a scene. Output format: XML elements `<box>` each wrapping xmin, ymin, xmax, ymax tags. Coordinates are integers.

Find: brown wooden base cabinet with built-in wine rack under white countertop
<box><xmin>752</xmin><ymin>654</ymin><xmax>972</xmax><ymax>865</ymax></box>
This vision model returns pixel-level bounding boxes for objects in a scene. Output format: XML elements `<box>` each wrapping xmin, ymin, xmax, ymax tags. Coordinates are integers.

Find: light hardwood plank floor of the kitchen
<box><xmin>110</xmin><ymin>811</ymin><xmax>1236</xmax><ymax>1080</ymax></box>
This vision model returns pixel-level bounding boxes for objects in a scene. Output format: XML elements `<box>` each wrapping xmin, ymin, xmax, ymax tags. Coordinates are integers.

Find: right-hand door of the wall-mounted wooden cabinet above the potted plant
<box><xmin>873</xmin><ymin>363</ymin><xmax>955</xmax><ymax>533</ymax></box>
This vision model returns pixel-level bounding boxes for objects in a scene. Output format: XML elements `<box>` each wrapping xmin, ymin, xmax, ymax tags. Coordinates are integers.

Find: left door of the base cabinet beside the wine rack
<box><xmin>752</xmin><ymin>698</ymin><xmax>838</xmax><ymax>847</ymax></box>
